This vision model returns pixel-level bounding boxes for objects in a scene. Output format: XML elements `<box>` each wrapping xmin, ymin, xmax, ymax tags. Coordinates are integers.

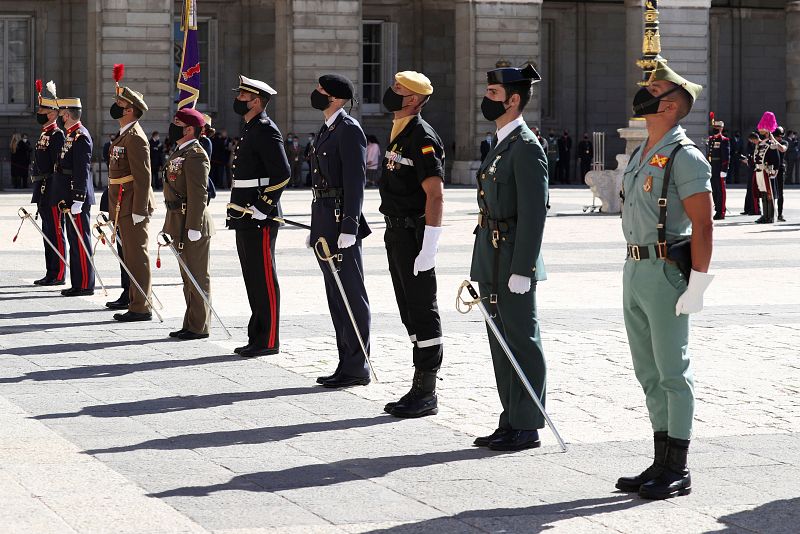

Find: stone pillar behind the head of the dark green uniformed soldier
<box><xmin>449</xmin><ymin>0</ymin><xmax>542</xmax><ymax>184</ymax></box>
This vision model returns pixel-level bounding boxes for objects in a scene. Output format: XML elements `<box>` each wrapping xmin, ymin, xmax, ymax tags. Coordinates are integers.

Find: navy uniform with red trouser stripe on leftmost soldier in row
<box><xmin>31</xmin><ymin>123</ymin><xmax>67</xmax><ymax>283</ymax></box>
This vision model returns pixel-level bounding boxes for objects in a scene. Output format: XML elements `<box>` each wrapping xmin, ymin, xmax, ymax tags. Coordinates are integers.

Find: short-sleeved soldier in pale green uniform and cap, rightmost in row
<box><xmin>616</xmin><ymin>61</ymin><xmax>714</xmax><ymax>499</ymax></box>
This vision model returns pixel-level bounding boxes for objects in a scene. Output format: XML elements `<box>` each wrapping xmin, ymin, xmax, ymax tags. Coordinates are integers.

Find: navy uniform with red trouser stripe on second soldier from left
<box><xmin>53</xmin><ymin>122</ymin><xmax>94</xmax><ymax>290</ymax></box>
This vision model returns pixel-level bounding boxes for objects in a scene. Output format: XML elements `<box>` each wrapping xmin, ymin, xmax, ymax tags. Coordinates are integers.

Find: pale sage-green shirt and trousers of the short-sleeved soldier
<box><xmin>622</xmin><ymin>126</ymin><xmax>711</xmax><ymax>440</ymax></box>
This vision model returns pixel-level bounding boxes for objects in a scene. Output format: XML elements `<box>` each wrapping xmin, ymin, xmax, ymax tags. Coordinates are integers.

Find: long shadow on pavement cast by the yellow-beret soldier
<box><xmin>84</xmin><ymin>415</ymin><xmax>402</xmax><ymax>454</ymax></box>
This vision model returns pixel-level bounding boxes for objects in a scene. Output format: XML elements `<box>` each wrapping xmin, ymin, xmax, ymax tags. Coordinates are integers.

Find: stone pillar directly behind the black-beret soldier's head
<box><xmin>275</xmin><ymin>0</ymin><xmax>362</xmax><ymax>140</ymax></box>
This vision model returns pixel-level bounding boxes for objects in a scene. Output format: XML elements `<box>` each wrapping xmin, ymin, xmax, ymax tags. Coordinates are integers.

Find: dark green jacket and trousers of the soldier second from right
<box><xmin>470</xmin><ymin>122</ymin><xmax>548</xmax><ymax>430</ymax></box>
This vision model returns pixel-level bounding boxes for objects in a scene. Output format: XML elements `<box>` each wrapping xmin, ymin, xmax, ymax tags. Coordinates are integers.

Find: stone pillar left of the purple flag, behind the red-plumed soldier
<box><xmin>85</xmin><ymin>0</ymin><xmax>175</xmax><ymax>153</ymax></box>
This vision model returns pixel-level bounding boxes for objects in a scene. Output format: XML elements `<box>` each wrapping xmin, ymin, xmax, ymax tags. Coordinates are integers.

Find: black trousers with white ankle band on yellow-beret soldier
<box><xmin>384</xmin><ymin>225</ymin><xmax>443</xmax><ymax>371</ymax></box>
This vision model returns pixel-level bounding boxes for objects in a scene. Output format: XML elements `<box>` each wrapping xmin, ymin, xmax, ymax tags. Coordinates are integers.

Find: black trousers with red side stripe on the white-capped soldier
<box><xmin>236</xmin><ymin>223</ymin><xmax>281</xmax><ymax>349</ymax></box>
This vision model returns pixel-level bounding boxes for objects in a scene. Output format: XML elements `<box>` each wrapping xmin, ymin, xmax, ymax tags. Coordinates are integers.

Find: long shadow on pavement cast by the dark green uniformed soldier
<box><xmin>148</xmin><ymin>448</ymin><xmax>502</xmax><ymax>498</ymax></box>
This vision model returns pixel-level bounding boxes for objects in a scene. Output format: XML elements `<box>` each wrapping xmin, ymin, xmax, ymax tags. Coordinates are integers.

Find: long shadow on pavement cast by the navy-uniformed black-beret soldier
<box><xmin>33</xmin><ymin>388</ymin><xmax>324</xmax><ymax>420</ymax></box>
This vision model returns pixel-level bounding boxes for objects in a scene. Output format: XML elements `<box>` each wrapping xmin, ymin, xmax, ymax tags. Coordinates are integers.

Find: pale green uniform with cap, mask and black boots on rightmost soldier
<box><xmin>616</xmin><ymin>61</ymin><xmax>711</xmax><ymax>499</ymax></box>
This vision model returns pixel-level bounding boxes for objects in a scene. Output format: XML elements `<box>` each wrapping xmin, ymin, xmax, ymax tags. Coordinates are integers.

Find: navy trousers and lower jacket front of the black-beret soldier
<box><xmin>311</xmin><ymin>198</ymin><xmax>371</xmax><ymax>377</ymax></box>
